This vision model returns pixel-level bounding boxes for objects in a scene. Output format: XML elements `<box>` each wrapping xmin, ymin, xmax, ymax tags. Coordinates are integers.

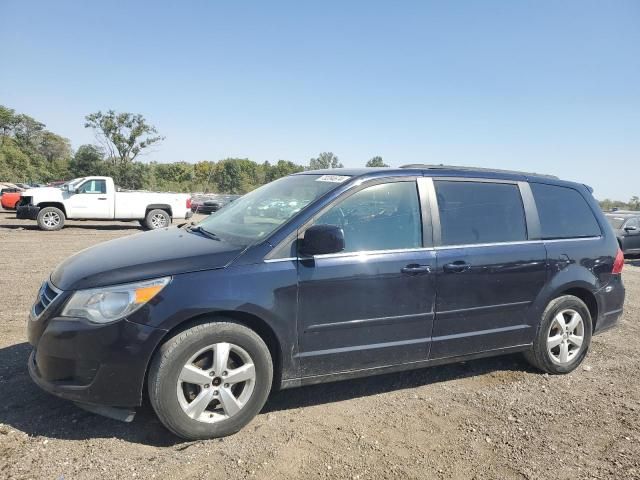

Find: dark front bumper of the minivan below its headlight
<box><xmin>28</xmin><ymin>316</ymin><xmax>165</xmax><ymax>407</ymax></box>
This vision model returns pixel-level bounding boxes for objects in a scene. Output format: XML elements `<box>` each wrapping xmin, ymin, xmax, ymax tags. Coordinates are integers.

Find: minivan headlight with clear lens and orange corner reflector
<box><xmin>61</xmin><ymin>277</ymin><xmax>171</xmax><ymax>323</ymax></box>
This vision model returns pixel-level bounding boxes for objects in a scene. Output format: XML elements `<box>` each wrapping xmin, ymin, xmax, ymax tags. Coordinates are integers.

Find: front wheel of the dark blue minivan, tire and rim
<box><xmin>148</xmin><ymin>320</ymin><xmax>273</xmax><ymax>440</ymax></box>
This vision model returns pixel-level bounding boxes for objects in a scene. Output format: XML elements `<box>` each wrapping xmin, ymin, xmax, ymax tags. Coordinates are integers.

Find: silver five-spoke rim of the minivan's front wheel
<box><xmin>177</xmin><ymin>342</ymin><xmax>256</xmax><ymax>423</ymax></box>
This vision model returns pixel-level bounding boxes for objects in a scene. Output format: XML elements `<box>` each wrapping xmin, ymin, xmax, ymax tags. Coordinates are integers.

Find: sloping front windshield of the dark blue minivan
<box><xmin>200</xmin><ymin>175</ymin><xmax>349</xmax><ymax>245</ymax></box>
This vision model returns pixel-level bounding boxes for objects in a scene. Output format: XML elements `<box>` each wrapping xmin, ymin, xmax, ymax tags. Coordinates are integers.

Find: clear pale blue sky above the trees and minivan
<box><xmin>0</xmin><ymin>0</ymin><xmax>640</xmax><ymax>200</ymax></box>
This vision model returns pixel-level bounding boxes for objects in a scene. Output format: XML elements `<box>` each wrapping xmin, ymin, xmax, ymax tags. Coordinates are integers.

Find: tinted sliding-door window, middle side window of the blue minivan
<box><xmin>433</xmin><ymin>180</ymin><xmax>527</xmax><ymax>245</ymax></box>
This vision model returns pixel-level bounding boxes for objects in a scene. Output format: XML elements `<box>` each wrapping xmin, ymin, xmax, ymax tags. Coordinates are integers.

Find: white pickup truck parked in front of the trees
<box><xmin>17</xmin><ymin>177</ymin><xmax>192</xmax><ymax>230</ymax></box>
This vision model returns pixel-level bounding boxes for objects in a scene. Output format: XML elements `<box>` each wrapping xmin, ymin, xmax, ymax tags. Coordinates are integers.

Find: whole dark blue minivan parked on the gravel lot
<box><xmin>28</xmin><ymin>165</ymin><xmax>624</xmax><ymax>439</ymax></box>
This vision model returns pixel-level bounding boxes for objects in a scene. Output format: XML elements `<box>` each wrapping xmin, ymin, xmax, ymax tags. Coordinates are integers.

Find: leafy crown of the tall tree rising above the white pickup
<box><xmin>84</xmin><ymin>110</ymin><xmax>165</xmax><ymax>165</ymax></box>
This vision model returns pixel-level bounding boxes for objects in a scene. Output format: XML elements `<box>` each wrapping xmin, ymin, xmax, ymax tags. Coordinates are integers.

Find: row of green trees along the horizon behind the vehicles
<box><xmin>0</xmin><ymin>105</ymin><xmax>387</xmax><ymax>194</ymax></box>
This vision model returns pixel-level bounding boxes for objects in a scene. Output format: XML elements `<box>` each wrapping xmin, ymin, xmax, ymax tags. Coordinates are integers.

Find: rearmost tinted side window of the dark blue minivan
<box><xmin>531</xmin><ymin>183</ymin><xmax>602</xmax><ymax>239</ymax></box>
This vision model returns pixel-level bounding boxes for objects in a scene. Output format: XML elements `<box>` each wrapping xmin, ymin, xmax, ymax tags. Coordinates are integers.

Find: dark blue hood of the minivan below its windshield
<box><xmin>51</xmin><ymin>227</ymin><xmax>244</xmax><ymax>290</ymax></box>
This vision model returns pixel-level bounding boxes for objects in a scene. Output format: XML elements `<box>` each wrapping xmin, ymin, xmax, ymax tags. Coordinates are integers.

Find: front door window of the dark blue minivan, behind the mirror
<box><xmin>314</xmin><ymin>181</ymin><xmax>422</xmax><ymax>252</ymax></box>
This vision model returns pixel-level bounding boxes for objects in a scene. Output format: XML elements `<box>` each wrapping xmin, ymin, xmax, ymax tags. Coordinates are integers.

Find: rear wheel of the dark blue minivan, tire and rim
<box><xmin>524</xmin><ymin>295</ymin><xmax>593</xmax><ymax>375</ymax></box>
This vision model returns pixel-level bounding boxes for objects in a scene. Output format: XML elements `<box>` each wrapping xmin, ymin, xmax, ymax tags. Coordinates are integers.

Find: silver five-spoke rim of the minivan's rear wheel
<box><xmin>547</xmin><ymin>308</ymin><xmax>584</xmax><ymax>365</ymax></box>
